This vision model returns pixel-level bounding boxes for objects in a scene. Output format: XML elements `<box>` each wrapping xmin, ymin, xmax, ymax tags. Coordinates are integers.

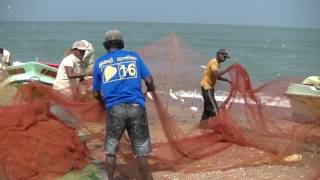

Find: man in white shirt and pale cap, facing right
<box><xmin>53</xmin><ymin>41</ymin><xmax>88</xmax><ymax>98</ymax></box>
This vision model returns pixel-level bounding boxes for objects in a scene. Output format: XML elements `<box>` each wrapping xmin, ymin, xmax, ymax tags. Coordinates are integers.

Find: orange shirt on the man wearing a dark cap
<box><xmin>200</xmin><ymin>58</ymin><xmax>220</xmax><ymax>90</ymax></box>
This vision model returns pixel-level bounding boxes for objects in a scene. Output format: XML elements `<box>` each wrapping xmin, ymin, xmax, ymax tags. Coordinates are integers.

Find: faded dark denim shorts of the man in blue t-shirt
<box><xmin>105</xmin><ymin>103</ymin><xmax>151</xmax><ymax>156</ymax></box>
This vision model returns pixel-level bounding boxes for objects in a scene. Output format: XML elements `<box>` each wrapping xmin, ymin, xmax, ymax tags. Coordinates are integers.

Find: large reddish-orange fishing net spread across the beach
<box><xmin>0</xmin><ymin>34</ymin><xmax>320</xmax><ymax>179</ymax></box>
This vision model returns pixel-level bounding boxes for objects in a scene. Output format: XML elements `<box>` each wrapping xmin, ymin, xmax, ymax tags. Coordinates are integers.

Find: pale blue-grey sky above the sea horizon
<box><xmin>0</xmin><ymin>0</ymin><xmax>320</xmax><ymax>28</ymax></box>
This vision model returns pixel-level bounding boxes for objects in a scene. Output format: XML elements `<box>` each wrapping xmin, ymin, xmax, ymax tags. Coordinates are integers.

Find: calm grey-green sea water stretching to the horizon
<box><xmin>0</xmin><ymin>22</ymin><xmax>320</xmax><ymax>83</ymax></box>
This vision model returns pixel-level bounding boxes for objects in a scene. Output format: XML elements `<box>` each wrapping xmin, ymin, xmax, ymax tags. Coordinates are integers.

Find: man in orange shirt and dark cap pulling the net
<box><xmin>200</xmin><ymin>49</ymin><xmax>230</xmax><ymax>122</ymax></box>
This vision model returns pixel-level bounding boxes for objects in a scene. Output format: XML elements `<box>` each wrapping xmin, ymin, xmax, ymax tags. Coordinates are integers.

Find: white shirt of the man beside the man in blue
<box><xmin>53</xmin><ymin>54</ymin><xmax>81</xmax><ymax>97</ymax></box>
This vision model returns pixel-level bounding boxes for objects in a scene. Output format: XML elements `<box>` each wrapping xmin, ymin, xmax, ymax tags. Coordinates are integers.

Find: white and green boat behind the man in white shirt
<box><xmin>6</xmin><ymin>62</ymin><xmax>58</xmax><ymax>85</ymax></box>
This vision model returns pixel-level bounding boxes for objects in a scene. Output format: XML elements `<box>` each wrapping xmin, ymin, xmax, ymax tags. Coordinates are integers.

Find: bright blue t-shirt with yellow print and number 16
<box><xmin>93</xmin><ymin>50</ymin><xmax>150</xmax><ymax>110</ymax></box>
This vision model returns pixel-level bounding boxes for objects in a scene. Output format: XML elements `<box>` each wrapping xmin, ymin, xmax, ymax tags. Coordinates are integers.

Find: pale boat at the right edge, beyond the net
<box><xmin>285</xmin><ymin>84</ymin><xmax>320</xmax><ymax>122</ymax></box>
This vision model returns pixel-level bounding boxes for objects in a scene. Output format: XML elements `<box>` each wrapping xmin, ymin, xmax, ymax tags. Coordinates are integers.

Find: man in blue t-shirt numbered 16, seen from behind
<box><xmin>93</xmin><ymin>30</ymin><xmax>155</xmax><ymax>180</ymax></box>
